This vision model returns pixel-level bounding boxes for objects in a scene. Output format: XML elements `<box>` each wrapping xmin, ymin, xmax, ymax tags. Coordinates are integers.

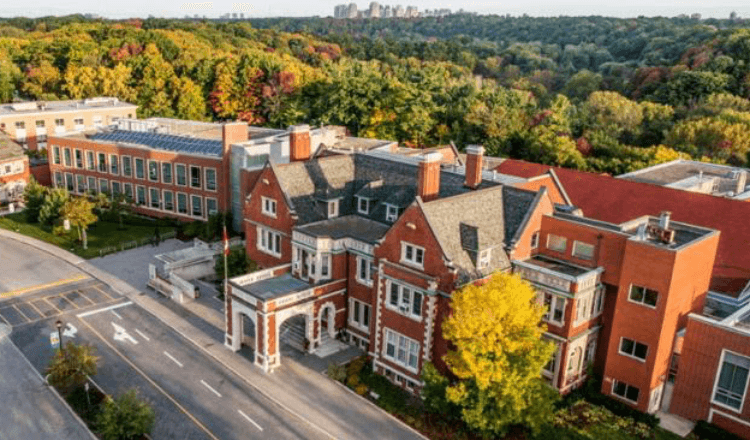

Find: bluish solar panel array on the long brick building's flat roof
<box><xmin>90</xmin><ymin>130</ymin><xmax>222</xmax><ymax>157</ymax></box>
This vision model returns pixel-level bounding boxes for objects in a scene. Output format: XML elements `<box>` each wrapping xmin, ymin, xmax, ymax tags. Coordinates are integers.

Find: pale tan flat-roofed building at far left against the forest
<box><xmin>0</xmin><ymin>97</ymin><xmax>137</xmax><ymax>150</ymax></box>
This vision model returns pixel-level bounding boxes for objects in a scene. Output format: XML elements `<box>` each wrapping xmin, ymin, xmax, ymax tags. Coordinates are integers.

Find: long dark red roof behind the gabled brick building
<box><xmin>495</xmin><ymin>159</ymin><xmax>750</xmax><ymax>296</ymax></box>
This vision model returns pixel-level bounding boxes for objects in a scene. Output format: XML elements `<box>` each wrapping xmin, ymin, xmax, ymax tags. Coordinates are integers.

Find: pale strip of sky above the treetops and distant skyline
<box><xmin>0</xmin><ymin>0</ymin><xmax>750</xmax><ymax>18</ymax></box>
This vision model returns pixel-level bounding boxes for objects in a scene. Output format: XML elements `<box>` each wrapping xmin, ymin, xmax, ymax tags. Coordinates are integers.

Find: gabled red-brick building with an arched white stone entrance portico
<box><xmin>226</xmin><ymin>136</ymin><xmax>719</xmax><ymax>422</ymax></box>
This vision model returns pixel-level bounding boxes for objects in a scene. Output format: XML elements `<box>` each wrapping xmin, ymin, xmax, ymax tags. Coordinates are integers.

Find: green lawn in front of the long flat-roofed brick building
<box><xmin>0</xmin><ymin>212</ymin><xmax>174</xmax><ymax>258</ymax></box>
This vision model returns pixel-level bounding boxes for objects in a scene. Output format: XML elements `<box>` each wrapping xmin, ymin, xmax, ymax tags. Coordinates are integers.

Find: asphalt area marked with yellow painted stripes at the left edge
<box><xmin>0</xmin><ymin>279</ymin><xmax>121</xmax><ymax>327</ymax></box>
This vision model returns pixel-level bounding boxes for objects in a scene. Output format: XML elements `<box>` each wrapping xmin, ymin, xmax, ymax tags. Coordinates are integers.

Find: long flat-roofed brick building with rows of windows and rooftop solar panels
<box><xmin>48</xmin><ymin>118</ymin><xmax>396</xmax><ymax>225</ymax></box>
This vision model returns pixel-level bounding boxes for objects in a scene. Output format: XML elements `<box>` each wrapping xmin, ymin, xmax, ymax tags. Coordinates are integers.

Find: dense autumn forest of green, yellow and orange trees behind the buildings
<box><xmin>0</xmin><ymin>14</ymin><xmax>750</xmax><ymax>174</ymax></box>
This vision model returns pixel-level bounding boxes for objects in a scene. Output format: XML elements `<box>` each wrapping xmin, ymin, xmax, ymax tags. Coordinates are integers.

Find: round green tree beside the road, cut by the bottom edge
<box><xmin>96</xmin><ymin>389</ymin><xmax>156</xmax><ymax>440</ymax></box>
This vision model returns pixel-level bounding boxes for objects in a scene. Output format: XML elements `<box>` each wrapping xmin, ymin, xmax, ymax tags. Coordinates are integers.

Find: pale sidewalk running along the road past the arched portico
<box><xmin>0</xmin><ymin>230</ymin><xmax>426</xmax><ymax>439</ymax></box>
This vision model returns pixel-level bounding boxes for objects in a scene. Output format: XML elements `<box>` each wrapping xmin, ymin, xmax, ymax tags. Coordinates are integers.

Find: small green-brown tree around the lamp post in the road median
<box><xmin>46</xmin><ymin>341</ymin><xmax>99</xmax><ymax>391</ymax></box>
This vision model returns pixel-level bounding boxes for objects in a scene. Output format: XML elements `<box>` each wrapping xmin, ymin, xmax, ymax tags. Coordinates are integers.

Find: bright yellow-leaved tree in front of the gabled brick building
<box><xmin>428</xmin><ymin>273</ymin><xmax>557</xmax><ymax>437</ymax></box>
